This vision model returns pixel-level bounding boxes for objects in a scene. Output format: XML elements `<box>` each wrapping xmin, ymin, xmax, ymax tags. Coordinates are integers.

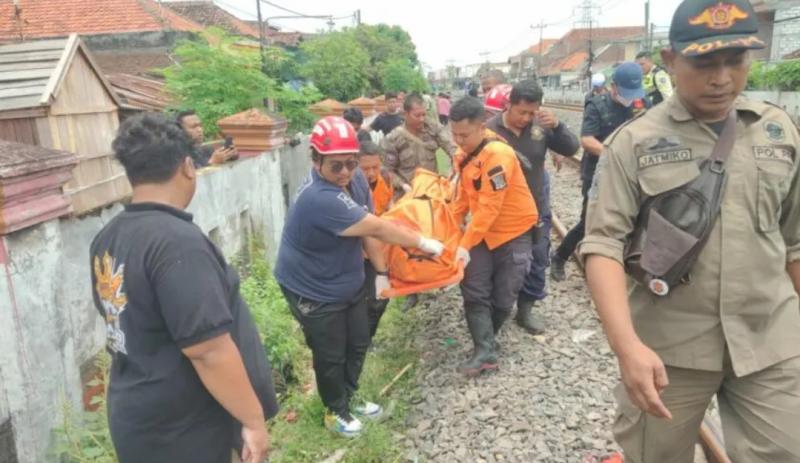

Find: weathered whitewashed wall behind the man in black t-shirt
<box><xmin>0</xmin><ymin>150</ymin><xmax>292</xmax><ymax>463</ymax></box>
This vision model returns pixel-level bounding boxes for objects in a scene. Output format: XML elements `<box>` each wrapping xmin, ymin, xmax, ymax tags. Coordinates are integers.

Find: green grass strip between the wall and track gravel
<box><xmin>270</xmin><ymin>300</ymin><xmax>419</xmax><ymax>463</ymax></box>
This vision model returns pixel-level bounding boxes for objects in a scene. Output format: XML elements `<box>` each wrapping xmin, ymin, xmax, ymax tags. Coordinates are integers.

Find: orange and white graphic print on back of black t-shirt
<box><xmin>94</xmin><ymin>251</ymin><xmax>128</xmax><ymax>355</ymax></box>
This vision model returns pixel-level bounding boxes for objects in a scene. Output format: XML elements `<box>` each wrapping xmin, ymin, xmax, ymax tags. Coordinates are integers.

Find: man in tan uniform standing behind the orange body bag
<box><xmin>382</xmin><ymin>93</ymin><xmax>456</xmax><ymax>193</ymax></box>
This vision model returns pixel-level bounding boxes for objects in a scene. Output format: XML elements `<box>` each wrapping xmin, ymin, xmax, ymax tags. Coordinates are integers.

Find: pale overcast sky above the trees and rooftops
<box><xmin>209</xmin><ymin>0</ymin><xmax>680</xmax><ymax>69</ymax></box>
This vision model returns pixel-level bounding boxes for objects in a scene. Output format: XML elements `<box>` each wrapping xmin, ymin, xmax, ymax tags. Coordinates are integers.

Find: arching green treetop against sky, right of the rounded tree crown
<box><xmin>349</xmin><ymin>24</ymin><xmax>418</xmax><ymax>92</ymax></box>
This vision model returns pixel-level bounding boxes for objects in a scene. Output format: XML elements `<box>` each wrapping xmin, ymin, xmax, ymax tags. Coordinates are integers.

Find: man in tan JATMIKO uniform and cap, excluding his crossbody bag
<box><xmin>579</xmin><ymin>0</ymin><xmax>800</xmax><ymax>463</ymax></box>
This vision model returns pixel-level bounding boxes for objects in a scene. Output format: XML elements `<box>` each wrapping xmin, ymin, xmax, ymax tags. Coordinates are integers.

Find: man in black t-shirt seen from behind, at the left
<box><xmin>90</xmin><ymin>114</ymin><xmax>278</xmax><ymax>463</ymax></box>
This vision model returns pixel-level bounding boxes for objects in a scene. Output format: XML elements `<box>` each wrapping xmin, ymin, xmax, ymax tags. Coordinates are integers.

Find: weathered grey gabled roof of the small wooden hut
<box><xmin>0</xmin><ymin>34</ymin><xmax>120</xmax><ymax>111</ymax></box>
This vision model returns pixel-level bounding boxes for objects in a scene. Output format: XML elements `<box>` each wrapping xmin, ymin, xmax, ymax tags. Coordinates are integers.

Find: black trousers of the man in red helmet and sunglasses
<box><xmin>281</xmin><ymin>287</ymin><xmax>370</xmax><ymax>416</ymax></box>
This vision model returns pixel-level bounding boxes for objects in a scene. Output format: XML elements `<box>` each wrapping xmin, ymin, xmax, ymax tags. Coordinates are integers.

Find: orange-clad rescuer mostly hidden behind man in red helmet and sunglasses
<box><xmin>358</xmin><ymin>140</ymin><xmax>394</xmax><ymax>339</ymax></box>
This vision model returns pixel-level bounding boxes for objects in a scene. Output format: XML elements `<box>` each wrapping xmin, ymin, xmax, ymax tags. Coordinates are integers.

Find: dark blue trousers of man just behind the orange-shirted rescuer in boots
<box><xmin>519</xmin><ymin>171</ymin><xmax>553</xmax><ymax>301</ymax></box>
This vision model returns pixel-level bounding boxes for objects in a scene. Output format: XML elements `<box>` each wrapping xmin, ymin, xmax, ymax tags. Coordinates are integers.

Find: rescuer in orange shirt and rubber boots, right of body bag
<box><xmin>450</xmin><ymin>97</ymin><xmax>538</xmax><ymax>377</ymax></box>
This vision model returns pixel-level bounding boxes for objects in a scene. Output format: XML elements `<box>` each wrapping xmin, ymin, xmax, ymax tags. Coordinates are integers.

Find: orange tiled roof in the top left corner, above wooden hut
<box><xmin>0</xmin><ymin>0</ymin><xmax>202</xmax><ymax>41</ymax></box>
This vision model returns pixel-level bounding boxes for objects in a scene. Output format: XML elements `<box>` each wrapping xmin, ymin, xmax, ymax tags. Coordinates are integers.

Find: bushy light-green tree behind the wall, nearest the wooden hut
<box><xmin>164</xmin><ymin>29</ymin><xmax>276</xmax><ymax>137</ymax></box>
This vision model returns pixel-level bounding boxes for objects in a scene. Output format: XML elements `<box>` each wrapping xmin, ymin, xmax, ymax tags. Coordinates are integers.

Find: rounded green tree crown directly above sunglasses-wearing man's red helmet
<box><xmin>301</xmin><ymin>32</ymin><xmax>369</xmax><ymax>101</ymax></box>
